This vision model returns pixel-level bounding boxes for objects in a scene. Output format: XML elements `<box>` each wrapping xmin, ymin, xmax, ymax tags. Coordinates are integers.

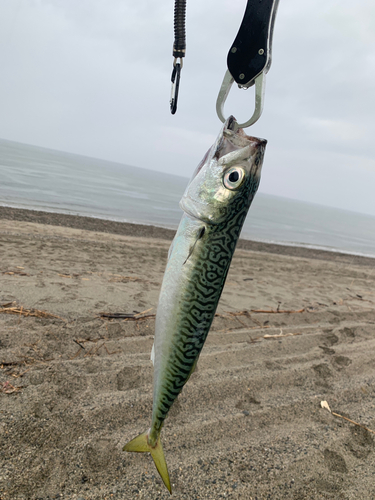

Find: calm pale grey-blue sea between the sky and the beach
<box><xmin>0</xmin><ymin>139</ymin><xmax>375</xmax><ymax>257</ymax></box>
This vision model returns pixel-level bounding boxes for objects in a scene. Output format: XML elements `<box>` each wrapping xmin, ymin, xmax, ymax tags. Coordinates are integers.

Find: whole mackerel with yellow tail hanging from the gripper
<box><xmin>124</xmin><ymin>116</ymin><xmax>267</xmax><ymax>493</ymax></box>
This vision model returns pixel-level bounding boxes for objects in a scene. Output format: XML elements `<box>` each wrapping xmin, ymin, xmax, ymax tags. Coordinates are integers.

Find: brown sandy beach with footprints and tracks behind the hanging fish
<box><xmin>0</xmin><ymin>208</ymin><xmax>375</xmax><ymax>500</ymax></box>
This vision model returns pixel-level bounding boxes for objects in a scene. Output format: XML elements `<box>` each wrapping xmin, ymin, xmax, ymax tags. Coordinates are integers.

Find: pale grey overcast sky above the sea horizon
<box><xmin>0</xmin><ymin>0</ymin><xmax>375</xmax><ymax>215</ymax></box>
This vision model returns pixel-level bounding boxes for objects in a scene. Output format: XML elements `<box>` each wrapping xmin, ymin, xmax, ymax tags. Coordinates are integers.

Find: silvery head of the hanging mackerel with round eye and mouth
<box><xmin>180</xmin><ymin>116</ymin><xmax>267</xmax><ymax>224</ymax></box>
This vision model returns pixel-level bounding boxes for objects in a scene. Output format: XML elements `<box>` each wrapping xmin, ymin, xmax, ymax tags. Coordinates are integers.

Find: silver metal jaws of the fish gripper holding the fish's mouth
<box><xmin>216</xmin><ymin>70</ymin><xmax>266</xmax><ymax>128</ymax></box>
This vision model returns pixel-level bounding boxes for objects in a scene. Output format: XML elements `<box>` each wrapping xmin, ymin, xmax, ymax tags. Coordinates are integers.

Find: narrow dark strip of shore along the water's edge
<box><xmin>0</xmin><ymin>206</ymin><xmax>375</xmax><ymax>267</ymax></box>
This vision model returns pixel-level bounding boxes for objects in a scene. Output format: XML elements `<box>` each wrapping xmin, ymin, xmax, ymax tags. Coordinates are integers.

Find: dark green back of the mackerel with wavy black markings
<box><xmin>152</xmin><ymin>172</ymin><xmax>259</xmax><ymax>430</ymax></box>
